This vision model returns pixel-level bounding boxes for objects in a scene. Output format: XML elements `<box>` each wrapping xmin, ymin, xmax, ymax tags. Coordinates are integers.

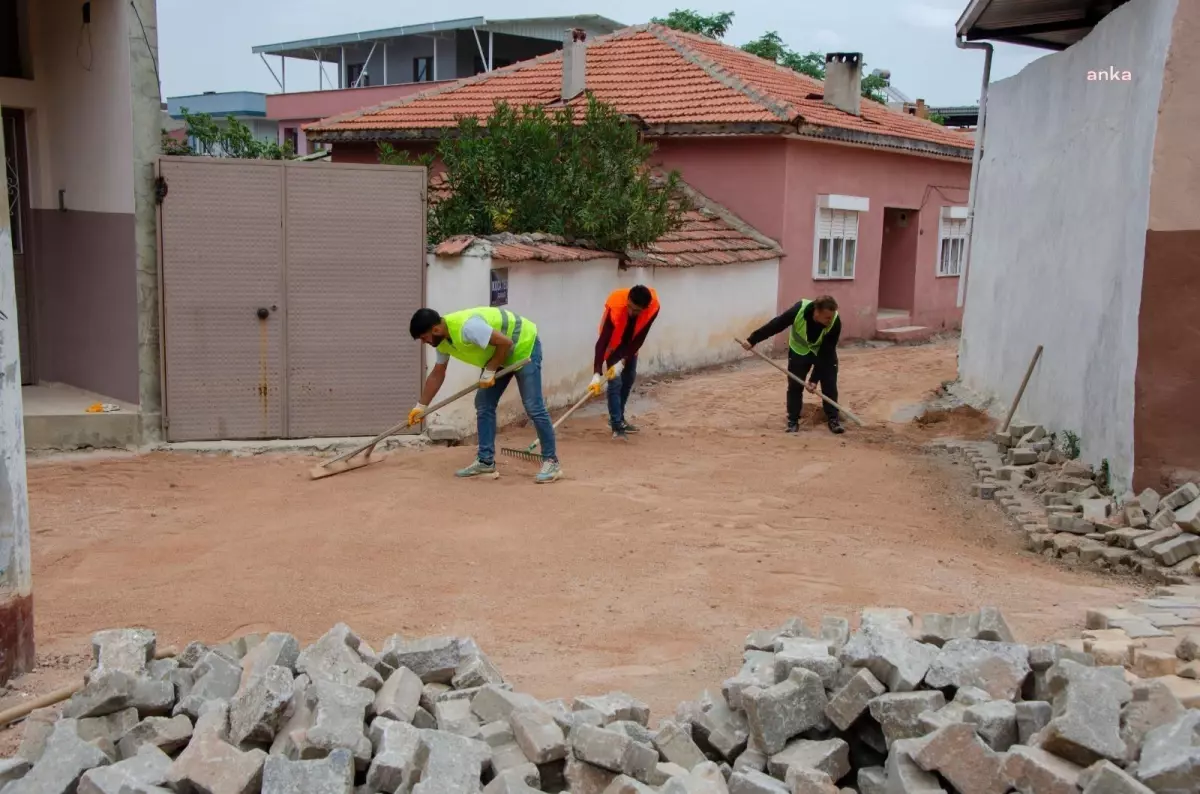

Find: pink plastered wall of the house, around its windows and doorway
<box><xmin>655</xmin><ymin>137</ymin><xmax>971</xmax><ymax>338</ymax></box>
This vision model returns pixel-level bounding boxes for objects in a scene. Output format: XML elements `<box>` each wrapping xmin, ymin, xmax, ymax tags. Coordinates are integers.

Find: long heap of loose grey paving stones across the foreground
<box><xmin>0</xmin><ymin>604</ymin><xmax>1200</xmax><ymax>794</ymax></box>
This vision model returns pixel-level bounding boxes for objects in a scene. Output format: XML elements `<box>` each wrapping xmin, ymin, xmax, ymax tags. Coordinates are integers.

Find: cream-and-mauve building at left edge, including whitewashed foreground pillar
<box><xmin>0</xmin><ymin>0</ymin><xmax>162</xmax><ymax>684</ymax></box>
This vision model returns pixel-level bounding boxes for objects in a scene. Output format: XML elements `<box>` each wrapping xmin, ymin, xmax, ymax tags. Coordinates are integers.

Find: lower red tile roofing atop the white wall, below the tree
<box><xmin>430</xmin><ymin>175</ymin><xmax>784</xmax><ymax>267</ymax></box>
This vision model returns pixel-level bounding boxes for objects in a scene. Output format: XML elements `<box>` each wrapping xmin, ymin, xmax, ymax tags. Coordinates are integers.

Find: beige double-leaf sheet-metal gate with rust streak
<box><xmin>158</xmin><ymin>157</ymin><xmax>425</xmax><ymax>441</ymax></box>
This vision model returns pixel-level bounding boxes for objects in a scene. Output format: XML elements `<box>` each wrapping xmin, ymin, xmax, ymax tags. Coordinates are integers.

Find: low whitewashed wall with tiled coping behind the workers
<box><xmin>426</xmin><ymin>255</ymin><xmax>779</xmax><ymax>437</ymax></box>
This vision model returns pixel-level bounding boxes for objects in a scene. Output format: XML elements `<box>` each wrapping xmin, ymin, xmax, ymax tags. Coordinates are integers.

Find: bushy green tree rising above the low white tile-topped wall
<box><xmin>393</xmin><ymin>97</ymin><xmax>686</xmax><ymax>252</ymax></box>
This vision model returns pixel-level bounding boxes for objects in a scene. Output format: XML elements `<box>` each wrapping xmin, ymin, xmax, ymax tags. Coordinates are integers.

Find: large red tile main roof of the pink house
<box><xmin>305</xmin><ymin>24</ymin><xmax>973</xmax><ymax>158</ymax></box>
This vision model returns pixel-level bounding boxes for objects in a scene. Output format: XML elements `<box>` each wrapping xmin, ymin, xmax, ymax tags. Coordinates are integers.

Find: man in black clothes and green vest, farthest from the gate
<box><xmin>743</xmin><ymin>295</ymin><xmax>846</xmax><ymax>433</ymax></box>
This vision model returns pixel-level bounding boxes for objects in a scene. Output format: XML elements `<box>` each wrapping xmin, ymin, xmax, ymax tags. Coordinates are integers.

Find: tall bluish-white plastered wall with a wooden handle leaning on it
<box><xmin>959</xmin><ymin>0</ymin><xmax>1177</xmax><ymax>486</ymax></box>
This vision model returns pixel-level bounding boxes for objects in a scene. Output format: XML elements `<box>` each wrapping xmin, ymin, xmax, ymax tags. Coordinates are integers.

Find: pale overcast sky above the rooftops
<box><xmin>158</xmin><ymin>0</ymin><xmax>1046</xmax><ymax>106</ymax></box>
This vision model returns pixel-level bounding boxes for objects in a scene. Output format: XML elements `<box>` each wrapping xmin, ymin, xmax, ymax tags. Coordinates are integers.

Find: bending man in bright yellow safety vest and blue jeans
<box><xmin>408</xmin><ymin>307</ymin><xmax>563</xmax><ymax>483</ymax></box>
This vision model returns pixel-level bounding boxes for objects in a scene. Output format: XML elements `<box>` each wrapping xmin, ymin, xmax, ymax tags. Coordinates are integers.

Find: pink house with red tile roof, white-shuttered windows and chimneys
<box><xmin>306</xmin><ymin>25</ymin><xmax>973</xmax><ymax>339</ymax></box>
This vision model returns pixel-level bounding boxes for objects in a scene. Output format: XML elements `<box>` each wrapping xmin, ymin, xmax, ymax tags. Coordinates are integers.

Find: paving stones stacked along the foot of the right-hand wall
<box><xmin>935</xmin><ymin>425</ymin><xmax>1200</xmax><ymax>584</ymax></box>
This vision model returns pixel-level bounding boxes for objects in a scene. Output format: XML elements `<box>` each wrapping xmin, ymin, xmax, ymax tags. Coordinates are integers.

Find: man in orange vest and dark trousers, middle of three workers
<box><xmin>588</xmin><ymin>284</ymin><xmax>659</xmax><ymax>441</ymax></box>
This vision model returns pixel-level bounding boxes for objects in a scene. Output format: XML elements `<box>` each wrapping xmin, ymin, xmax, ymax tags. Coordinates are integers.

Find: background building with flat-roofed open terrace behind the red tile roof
<box><xmin>253</xmin><ymin>14</ymin><xmax>622</xmax><ymax>155</ymax></box>
